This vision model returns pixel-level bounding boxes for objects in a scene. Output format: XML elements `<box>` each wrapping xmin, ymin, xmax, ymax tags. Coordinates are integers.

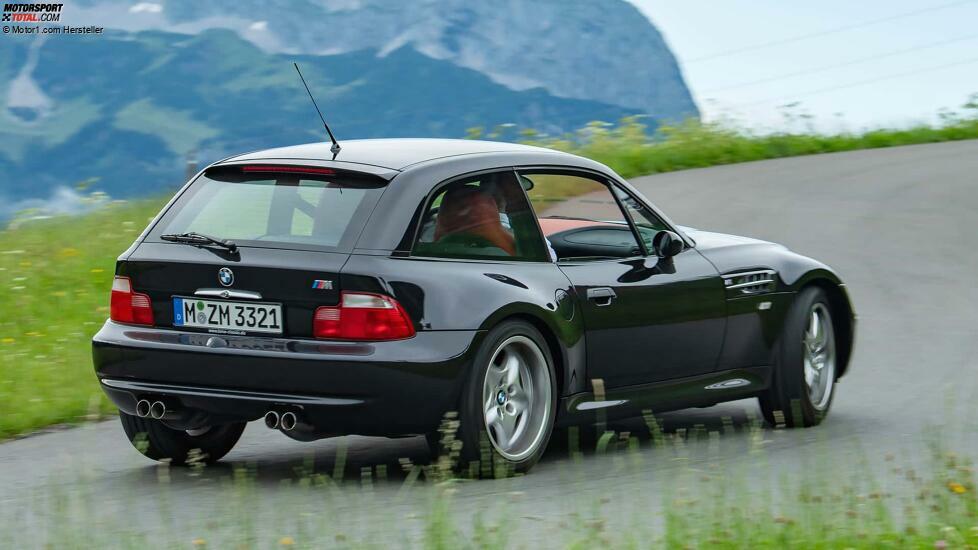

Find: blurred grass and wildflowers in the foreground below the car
<box><xmin>0</xmin><ymin>416</ymin><xmax>978</xmax><ymax>550</ymax></box>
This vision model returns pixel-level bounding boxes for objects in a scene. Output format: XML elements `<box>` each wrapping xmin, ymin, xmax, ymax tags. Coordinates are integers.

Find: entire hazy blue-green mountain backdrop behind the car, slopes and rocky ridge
<box><xmin>0</xmin><ymin>0</ymin><xmax>697</xmax><ymax>218</ymax></box>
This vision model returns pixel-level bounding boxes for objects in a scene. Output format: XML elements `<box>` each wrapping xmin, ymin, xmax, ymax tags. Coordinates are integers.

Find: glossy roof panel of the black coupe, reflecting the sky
<box><xmin>216</xmin><ymin>138</ymin><xmax>560</xmax><ymax>170</ymax></box>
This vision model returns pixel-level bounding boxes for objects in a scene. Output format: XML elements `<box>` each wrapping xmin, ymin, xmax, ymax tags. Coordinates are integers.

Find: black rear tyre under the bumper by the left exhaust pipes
<box><xmin>119</xmin><ymin>411</ymin><xmax>245</xmax><ymax>466</ymax></box>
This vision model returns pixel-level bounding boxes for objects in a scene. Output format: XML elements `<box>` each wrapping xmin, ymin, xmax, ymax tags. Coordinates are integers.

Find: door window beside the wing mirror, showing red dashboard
<box><xmin>520</xmin><ymin>170</ymin><xmax>642</xmax><ymax>261</ymax></box>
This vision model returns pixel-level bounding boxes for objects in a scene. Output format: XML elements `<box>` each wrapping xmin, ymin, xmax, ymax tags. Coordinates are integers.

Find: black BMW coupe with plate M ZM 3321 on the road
<box><xmin>93</xmin><ymin>139</ymin><xmax>855</xmax><ymax>471</ymax></box>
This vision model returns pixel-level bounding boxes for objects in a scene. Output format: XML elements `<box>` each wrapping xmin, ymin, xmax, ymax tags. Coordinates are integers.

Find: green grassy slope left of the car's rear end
<box><xmin>0</xmin><ymin>200</ymin><xmax>161</xmax><ymax>439</ymax></box>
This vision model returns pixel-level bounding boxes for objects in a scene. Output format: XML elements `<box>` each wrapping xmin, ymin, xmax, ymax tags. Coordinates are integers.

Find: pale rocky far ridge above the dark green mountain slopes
<box><xmin>68</xmin><ymin>0</ymin><xmax>697</xmax><ymax>119</ymax></box>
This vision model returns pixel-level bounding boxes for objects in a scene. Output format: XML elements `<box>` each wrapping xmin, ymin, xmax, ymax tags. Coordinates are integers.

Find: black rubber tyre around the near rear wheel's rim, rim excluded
<box><xmin>458</xmin><ymin>321</ymin><xmax>558</xmax><ymax>477</ymax></box>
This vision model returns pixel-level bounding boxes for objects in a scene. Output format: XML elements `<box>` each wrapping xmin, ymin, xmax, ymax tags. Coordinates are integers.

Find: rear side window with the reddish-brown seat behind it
<box><xmin>412</xmin><ymin>171</ymin><xmax>548</xmax><ymax>261</ymax></box>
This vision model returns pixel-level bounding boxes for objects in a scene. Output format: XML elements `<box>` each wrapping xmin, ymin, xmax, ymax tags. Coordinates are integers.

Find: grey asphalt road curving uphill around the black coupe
<box><xmin>0</xmin><ymin>141</ymin><xmax>978</xmax><ymax>542</ymax></box>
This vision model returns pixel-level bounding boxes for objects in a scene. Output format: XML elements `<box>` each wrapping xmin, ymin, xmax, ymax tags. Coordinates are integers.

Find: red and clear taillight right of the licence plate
<box><xmin>312</xmin><ymin>292</ymin><xmax>414</xmax><ymax>340</ymax></box>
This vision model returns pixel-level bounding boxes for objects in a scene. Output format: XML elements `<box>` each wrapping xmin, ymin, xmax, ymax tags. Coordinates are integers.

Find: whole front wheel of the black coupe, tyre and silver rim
<box><xmin>760</xmin><ymin>287</ymin><xmax>836</xmax><ymax>427</ymax></box>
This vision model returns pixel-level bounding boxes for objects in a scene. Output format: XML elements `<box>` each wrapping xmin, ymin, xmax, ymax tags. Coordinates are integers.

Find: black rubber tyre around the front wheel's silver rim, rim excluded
<box><xmin>758</xmin><ymin>287</ymin><xmax>838</xmax><ymax>428</ymax></box>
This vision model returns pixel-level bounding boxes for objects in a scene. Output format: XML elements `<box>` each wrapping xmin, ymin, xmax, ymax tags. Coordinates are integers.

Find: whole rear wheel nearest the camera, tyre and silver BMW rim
<box><xmin>460</xmin><ymin>321</ymin><xmax>557</xmax><ymax>471</ymax></box>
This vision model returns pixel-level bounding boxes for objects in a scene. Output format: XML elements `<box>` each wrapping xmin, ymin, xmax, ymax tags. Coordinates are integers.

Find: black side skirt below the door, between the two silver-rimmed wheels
<box><xmin>557</xmin><ymin>367</ymin><xmax>771</xmax><ymax>426</ymax></box>
